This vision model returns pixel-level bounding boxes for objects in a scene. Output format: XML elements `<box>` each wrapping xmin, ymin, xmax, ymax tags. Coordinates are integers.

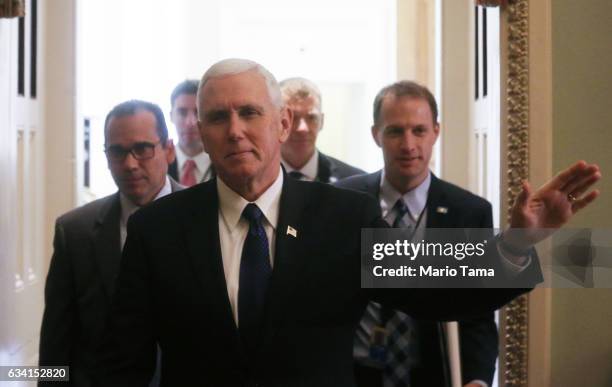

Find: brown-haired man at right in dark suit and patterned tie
<box><xmin>337</xmin><ymin>81</ymin><xmax>498</xmax><ymax>387</ymax></box>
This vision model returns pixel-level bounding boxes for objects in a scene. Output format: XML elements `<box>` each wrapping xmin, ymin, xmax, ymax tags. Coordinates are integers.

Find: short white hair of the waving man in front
<box><xmin>198</xmin><ymin>58</ymin><xmax>283</xmax><ymax>119</ymax></box>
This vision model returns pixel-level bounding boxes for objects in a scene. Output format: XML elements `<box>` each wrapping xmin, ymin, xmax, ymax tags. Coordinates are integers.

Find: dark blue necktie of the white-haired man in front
<box><xmin>238</xmin><ymin>203</ymin><xmax>272</xmax><ymax>354</ymax></box>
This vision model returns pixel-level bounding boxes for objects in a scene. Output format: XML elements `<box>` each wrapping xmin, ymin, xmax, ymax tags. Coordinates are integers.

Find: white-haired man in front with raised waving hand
<box><xmin>99</xmin><ymin>59</ymin><xmax>598</xmax><ymax>387</ymax></box>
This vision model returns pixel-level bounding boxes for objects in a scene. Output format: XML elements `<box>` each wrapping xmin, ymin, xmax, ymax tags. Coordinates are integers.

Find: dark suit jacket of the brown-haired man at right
<box><xmin>336</xmin><ymin>171</ymin><xmax>498</xmax><ymax>387</ymax></box>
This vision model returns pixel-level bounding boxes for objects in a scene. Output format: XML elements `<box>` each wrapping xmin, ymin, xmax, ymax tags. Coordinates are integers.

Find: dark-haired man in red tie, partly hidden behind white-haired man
<box><xmin>168</xmin><ymin>79</ymin><xmax>214</xmax><ymax>187</ymax></box>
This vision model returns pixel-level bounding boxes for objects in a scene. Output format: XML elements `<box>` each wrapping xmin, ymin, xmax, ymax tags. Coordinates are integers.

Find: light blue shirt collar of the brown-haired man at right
<box><xmin>380</xmin><ymin>169</ymin><xmax>431</xmax><ymax>220</ymax></box>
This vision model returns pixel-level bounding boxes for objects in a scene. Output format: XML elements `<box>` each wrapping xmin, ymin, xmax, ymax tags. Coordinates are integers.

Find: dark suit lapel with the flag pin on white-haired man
<box><xmin>262</xmin><ymin>175</ymin><xmax>306</xmax><ymax>352</ymax></box>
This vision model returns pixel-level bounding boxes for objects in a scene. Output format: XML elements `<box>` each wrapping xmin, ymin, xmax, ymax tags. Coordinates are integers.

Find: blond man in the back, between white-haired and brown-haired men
<box><xmin>279</xmin><ymin>78</ymin><xmax>365</xmax><ymax>183</ymax></box>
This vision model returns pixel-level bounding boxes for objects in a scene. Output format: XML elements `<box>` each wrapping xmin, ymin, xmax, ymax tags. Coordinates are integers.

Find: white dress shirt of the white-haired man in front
<box><xmin>217</xmin><ymin>169</ymin><xmax>283</xmax><ymax>326</ymax></box>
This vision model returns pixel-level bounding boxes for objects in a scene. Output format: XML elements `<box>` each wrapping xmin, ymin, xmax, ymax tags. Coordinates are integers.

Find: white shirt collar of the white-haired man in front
<box><xmin>217</xmin><ymin>168</ymin><xmax>283</xmax><ymax>230</ymax></box>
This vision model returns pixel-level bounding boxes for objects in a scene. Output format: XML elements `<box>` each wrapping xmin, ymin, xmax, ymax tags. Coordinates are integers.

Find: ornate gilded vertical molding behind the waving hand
<box><xmin>500</xmin><ymin>0</ymin><xmax>529</xmax><ymax>387</ymax></box>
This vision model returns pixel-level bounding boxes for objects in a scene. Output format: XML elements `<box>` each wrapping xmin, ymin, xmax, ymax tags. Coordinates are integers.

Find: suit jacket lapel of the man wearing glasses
<box><xmin>93</xmin><ymin>193</ymin><xmax>121</xmax><ymax>298</ymax></box>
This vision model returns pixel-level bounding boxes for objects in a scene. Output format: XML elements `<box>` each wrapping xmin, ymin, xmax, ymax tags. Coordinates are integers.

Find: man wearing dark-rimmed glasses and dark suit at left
<box><xmin>39</xmin><ymin>100</ymin><xmax>181</xmax><ymax>386</ymax></box>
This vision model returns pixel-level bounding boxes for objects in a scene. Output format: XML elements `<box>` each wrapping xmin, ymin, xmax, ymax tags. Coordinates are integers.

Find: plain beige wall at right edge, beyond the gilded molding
<box><xmin>551</xmin><ymin>0</ymin><xmax>612</xmax><ymax>387</ymax></box>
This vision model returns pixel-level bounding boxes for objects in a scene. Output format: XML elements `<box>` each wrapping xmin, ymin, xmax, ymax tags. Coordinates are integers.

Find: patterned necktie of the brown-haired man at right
<box><xmin>381</xmin><ymin>198</ymin><xmax>416</xmax><ymax>387</ymax></box>
